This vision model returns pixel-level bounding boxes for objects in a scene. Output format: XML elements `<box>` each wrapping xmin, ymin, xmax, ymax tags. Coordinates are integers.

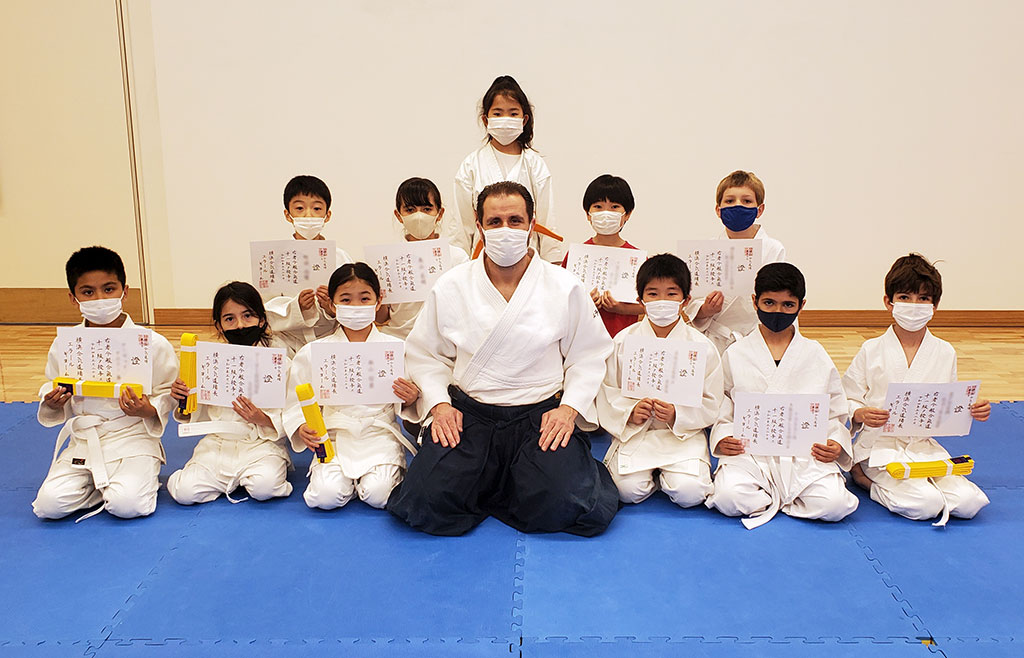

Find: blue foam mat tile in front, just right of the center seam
<box><xmin>522</xmin><ymin>495</ymin><xmax>919</xmax><ymax>640</ymax></box>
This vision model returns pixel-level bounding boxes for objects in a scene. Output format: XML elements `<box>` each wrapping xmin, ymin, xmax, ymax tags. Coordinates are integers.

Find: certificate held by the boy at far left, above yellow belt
<box><xmin>56</xmin><ymin>326</ymin><xmax>153</xmax><ymax>393</ymax></box>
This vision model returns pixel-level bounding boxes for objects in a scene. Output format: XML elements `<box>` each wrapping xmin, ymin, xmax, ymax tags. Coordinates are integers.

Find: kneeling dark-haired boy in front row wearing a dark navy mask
<box><xmin>706</xmin><ymin>263</ymin><xmax>857</xmax><ymax>528</ymax></box>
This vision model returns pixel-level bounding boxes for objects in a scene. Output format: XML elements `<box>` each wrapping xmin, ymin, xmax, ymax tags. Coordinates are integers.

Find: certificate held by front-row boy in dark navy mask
<box><xmin>732</xmin><ymin>393</ymin><xmax>828</xmax><ymax>457</ymax></box>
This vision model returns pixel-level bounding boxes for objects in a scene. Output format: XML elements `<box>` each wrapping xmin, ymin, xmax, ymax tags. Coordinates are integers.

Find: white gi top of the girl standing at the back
<box><xmin>442</xmin><ymin>143</ymin><xmax>566</xmax><ymax>263</ymax></box>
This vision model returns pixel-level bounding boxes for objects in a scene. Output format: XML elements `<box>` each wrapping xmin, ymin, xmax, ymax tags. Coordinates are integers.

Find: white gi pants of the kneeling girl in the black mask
<box><xmin>167</xmin><ymin>455</ymin><xmax>292</xmax><ymax>505</ymax></box>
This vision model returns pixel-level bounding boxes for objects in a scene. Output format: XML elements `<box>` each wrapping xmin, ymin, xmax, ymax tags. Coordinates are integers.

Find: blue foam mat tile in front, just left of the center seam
<box><xmin>101</xmin><ymin>494</ymin><xmax>516</xmax><ymax>641</ymax></box>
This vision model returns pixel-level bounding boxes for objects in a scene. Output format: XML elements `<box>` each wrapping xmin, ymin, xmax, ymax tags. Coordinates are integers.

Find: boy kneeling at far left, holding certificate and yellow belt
<box><xmin>32</xmin><ymin>247</ymin><xmax>178</xmax><ymax>519</ymax></box>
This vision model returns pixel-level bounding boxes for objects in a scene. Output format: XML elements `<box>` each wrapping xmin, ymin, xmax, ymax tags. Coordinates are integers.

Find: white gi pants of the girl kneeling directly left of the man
<box><xmin>302</xmin><ymin>458</ymin><xmax>404</xmax><ymax>510</ymax></box>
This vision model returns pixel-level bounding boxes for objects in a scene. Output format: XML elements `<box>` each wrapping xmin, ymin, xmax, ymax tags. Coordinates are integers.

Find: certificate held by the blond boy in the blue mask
<box><xmin>676</xmin><ymin>239</ymin><xmax>761</xmax><ymax>297</ymax></box>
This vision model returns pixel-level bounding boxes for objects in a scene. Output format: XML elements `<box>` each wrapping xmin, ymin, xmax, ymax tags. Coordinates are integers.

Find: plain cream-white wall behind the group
<box><xmin>9</xmin><ymin>0</ymin><xmax>1024</xmax><ymax>309</ymax></box>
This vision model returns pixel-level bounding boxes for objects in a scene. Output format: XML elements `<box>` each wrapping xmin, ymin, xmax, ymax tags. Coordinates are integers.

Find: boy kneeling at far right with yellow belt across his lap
<box><xmin>843</xmin><ymin>254</ymin><xmax>990</xmax><ymax>525</ymax></box>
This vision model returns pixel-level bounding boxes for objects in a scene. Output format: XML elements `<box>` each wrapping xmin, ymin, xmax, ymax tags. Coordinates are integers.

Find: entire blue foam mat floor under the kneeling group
<box><xmin>0</xmin><ymin>403</ymin><xmax>1024</xmax><ymax>658</ymax></box>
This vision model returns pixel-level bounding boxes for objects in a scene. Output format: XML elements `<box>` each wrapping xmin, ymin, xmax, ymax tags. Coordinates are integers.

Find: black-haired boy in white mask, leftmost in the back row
<box><xmin>264</xmin><ymin>175</ymin><xmax>352</xmax><ymax>358</ymax></box>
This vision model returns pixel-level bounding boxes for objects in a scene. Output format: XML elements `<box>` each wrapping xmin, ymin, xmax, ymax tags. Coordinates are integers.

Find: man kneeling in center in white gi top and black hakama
<box><xmin>388</xmin><ymin>181</ymin><xmax>618</xmax><ymax>536</ymax></box>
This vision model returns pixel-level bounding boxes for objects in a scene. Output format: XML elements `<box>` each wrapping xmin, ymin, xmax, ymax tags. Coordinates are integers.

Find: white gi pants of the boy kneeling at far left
<box><xmin>32</xmin><ymin>455</ymin><xmax>160</xmax><ymax>519</ymax></box>
